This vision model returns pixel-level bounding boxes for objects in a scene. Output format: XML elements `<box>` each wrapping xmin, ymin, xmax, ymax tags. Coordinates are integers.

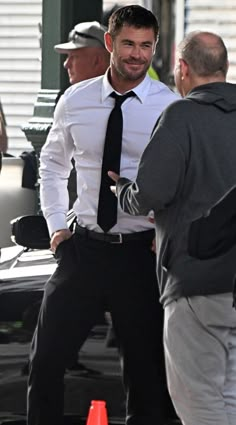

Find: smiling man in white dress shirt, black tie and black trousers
<box><xmin>28</xmin><ymin>5</ymin><xmax>178</xmax><ymax>425</ymax></box>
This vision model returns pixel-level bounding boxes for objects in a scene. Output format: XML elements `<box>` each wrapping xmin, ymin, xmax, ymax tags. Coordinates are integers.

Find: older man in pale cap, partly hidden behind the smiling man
<box><xmin>54</xmin><ymin>21</ymin><xmax>110</xmax><ymax>84</ymax></box>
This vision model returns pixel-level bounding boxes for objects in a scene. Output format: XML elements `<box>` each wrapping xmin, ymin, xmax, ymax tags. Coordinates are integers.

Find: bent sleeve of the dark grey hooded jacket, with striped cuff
<box><xmin>117</xmin><ymin>109</ymin><xmax>187</xmax><ymax>215</ymax></box>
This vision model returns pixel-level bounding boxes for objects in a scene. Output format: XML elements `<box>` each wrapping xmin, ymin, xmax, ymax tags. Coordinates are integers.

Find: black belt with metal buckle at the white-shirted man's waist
<box><xmin>75</xmin><ymin>224</ymin><xmax>155</xmax><ymax>244</ymax></box>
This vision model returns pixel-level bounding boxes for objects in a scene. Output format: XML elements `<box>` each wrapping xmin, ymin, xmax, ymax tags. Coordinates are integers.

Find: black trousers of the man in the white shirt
<box><xmin>27</xmin><ymin>234</ymin><xmax>173</xmax><ymax>425</ymax></box>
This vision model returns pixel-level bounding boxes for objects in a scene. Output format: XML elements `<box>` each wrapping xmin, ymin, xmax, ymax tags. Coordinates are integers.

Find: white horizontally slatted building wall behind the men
<box><xmin>0</xmin><ymin>0</ymin><xmax>236</xmax><ymax>156</ymax></box>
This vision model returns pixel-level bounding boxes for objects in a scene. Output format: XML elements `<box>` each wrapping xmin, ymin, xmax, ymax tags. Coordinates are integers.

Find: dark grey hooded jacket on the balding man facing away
<box><xmin>117</xmin><ymin>83</ymin><xmax>236</xmax><ymax>304</ymax></box>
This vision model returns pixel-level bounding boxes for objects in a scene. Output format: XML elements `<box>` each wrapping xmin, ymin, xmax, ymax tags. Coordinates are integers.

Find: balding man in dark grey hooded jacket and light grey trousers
<box><xmin>109</xmin><ymin>31</ymin><xmax>236</xmax><ymax>425</ymax></box>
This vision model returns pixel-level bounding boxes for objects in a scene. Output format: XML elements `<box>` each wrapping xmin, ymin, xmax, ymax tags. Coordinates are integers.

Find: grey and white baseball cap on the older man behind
<box><xmin>54</xmin><ymin>21</ymin><xmax>107</xmax><ymax>53</ymax></box>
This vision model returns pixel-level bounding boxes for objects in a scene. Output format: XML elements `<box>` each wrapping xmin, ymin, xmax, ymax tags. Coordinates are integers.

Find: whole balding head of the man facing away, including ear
<box><xmin>175</xmin><ymin>31</ymin><xmax>228</xmax><ymax>95</ymax></box>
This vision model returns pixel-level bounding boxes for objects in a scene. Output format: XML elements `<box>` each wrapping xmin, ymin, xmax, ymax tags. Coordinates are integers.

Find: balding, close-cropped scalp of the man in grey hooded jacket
<box><xmin>177</xmin><ymin>31</ymin><xmax>228</xmax><ymax>79</ymax></box>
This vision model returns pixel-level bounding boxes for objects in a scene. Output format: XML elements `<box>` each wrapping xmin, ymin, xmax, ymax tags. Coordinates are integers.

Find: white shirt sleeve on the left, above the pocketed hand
<box><xmin>39</xmin><ymin>96</ymin><xmax>74</xmax><ymax>235</ymax></box>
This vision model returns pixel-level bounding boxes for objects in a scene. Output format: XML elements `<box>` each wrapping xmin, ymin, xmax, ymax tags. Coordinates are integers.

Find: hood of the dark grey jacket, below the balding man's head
<box><xmin>186</xmin><ymin>82</ymin><xmax>236</xmax><ymax>112</ymax></box>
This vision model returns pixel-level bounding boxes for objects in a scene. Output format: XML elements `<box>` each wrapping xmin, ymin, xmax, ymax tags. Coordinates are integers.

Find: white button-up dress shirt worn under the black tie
<box><xmin>39</xmin><ymin>70</ymin><xmax>179</xmax><ymax>234</ymax></box>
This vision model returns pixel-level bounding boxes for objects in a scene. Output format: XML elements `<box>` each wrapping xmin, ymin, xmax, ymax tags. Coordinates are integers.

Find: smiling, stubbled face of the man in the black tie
<box><xmin>105</xmin><ymin>25</ymin><xmax>156</xmax><ymax>91</ymax></box>
